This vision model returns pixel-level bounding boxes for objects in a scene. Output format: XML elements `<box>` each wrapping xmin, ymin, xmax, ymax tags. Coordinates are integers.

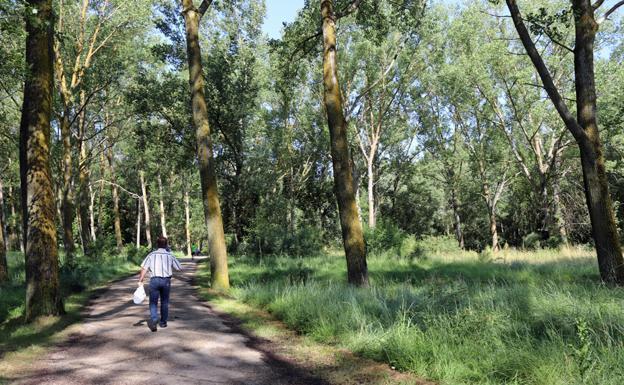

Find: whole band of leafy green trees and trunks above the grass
<box><xmin>0</xmin><ymin>0</ymin><xmax>624</xmax><ymax>319</ymax></box>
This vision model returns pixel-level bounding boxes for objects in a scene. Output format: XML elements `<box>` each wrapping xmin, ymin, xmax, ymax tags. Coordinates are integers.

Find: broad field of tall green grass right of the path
<box><xmin>200</xmin><ymin>249</ymin><xmax>624</xmax><ymax>385</ymax></box>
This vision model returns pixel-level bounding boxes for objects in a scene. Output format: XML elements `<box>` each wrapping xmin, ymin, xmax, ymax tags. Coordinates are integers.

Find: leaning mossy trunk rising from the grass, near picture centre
<box><xmin>321</xmin><ymin>0</ymin><xmax>368</xmax><ymax>286</ymax></box>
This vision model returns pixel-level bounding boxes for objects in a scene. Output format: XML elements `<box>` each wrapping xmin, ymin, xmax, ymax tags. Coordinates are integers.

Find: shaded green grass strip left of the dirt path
<box><xmin>0</xmin><ymin>253</ymin><xmax>137</xmax><ymax>359</ymax></box>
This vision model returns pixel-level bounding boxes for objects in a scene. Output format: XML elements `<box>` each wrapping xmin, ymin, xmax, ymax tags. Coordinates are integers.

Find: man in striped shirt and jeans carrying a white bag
<box><xmin>139</xmin><ymin>236</ymin><xmax>182</xmax><ymax>332</ymax></box>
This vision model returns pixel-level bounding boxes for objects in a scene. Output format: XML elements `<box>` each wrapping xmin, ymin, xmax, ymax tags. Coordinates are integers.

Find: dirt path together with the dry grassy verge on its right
<box><xmin>3</xmin><ymin>261</ymin><xmax>420</xmax><ymax>385</ymax></box>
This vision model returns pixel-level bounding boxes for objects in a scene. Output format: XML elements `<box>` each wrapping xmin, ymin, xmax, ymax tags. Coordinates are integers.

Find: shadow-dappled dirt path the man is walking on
<box><xmin>14</xmin><ymin>261</ymin><xmax>323</xmax><ymax>385</ymax></box>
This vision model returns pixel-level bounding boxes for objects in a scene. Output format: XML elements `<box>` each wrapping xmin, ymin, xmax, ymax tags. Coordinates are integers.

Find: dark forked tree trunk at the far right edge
<box><xmin>506</xmin><ymin>0</ymin><xmax>624</xmax><ymax>285</ymax></box>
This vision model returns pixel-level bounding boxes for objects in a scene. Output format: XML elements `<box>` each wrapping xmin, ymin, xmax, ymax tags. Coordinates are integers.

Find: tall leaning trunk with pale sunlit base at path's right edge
<box><xmin>182</xmin><ymin>0</ymin><xmax>230</xmax><ymax>290</ymax></box>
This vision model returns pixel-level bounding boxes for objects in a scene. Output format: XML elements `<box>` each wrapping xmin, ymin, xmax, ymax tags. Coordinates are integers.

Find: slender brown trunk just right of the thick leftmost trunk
<box><xmin>61</xmin><ymin>110</ymin><xmax>76</xmax><ymax>265</ymax></box>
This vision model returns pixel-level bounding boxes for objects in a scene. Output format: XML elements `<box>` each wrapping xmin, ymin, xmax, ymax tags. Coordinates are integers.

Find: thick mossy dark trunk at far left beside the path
<box><xmin>20</xmin><ymin>0</ymin><xmax>63</xmax><ymax>321</ymax></box>
